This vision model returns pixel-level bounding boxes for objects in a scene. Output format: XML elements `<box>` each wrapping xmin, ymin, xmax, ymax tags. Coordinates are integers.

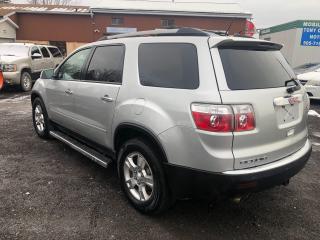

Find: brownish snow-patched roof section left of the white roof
<box><xmin>0</xmin><ymin>4</ymin><xmax>90</xmax><ymax>16</ymax></box>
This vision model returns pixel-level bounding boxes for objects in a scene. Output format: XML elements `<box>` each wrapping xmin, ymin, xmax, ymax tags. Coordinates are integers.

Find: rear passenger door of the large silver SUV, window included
<box><xmin>71</xmin><ymin>45</ymin><xmax>125</xmax><ymax>148</ymax></box>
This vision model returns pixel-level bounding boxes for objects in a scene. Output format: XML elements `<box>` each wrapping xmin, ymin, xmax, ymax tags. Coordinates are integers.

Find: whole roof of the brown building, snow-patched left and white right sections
<box><xmin>0</xmin><ymin>0</ymin><xmax>251</xmax><ymax>18</ymax></box>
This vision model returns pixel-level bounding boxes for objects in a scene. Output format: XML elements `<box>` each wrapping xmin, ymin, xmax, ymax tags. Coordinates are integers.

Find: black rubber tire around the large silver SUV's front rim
<box><xmin>32</xmin><ymin>98</ymin><xmax>50</xmax><ymax>139</ymax></box>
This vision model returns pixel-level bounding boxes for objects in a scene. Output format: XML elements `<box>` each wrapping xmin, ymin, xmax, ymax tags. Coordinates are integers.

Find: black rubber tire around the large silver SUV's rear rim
<box><xmin>118</xmin><ymin>138</ymin><xmax>173</xmax><ymax>214</ymax></box>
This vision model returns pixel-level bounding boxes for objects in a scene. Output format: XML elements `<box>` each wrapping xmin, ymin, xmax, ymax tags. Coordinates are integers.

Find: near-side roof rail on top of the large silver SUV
<box><xmin>105</xmin><ymin>28</ymin><xmax>213</xmax><ymax>41</ymax></box>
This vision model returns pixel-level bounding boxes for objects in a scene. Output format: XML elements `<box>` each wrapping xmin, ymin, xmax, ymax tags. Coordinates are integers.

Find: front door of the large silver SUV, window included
<box><xmin>46</xmin><ymin>48</ymin><xmax>92</xmax><ymax>130</ymax></box>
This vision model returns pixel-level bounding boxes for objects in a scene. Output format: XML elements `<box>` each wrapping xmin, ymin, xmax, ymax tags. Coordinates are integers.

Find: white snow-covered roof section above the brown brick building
<box><xmin>91</xmin><ymin>0</ymin><xmax>251</xmax><ymax>18</ymax></box>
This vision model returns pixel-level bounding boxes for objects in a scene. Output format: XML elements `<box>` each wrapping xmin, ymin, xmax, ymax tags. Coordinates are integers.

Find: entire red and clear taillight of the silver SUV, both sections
<box><xmin>191</xmin><ymin>103</ymin><xmax>255</xmax><ymax>132</ymax></box>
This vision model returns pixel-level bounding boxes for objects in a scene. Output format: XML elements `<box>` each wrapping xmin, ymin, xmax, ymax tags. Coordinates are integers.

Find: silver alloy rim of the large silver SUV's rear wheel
<box><xmin>123</xmin><ymin>152</ymin><xmax>154</xmax><ymax>202</ymax></box>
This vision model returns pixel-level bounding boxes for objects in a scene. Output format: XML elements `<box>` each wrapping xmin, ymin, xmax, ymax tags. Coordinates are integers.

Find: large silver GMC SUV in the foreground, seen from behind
<box><xmin>32</xmin><ymin>28</ymin><xmax>311</xmax><ymax>213</ymax></box>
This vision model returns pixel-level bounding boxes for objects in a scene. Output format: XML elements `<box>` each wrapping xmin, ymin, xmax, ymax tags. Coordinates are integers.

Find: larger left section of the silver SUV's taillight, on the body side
<box><xmin>191</xmin><ymin>104</ymin><xmax>233</xmax><ymax>132</ymax></box>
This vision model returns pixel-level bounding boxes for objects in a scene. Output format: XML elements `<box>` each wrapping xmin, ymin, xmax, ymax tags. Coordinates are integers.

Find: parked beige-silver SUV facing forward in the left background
<box><xmin>0</xmin><ymin>43</ymin><xmax>63</xmax><ymax>91</ymax></box>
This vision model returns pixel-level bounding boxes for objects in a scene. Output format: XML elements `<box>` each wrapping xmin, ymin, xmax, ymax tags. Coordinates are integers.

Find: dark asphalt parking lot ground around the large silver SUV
<box><xmin>0</xmin><ymin>89</ymin><xmax>320</xmax><ymax>239</ymax></box>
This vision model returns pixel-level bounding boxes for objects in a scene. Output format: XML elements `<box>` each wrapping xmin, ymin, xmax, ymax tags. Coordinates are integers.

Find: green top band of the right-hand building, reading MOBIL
<box><xmin>260</xmin><ymin>20</ymin><xmax>320</xmax><ymax>36</ymax></box>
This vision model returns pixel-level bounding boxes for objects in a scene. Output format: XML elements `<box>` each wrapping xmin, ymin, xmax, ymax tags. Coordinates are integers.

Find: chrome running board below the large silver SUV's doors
<box><xmin>50</xmin><ymin>131</ymin><xmax>112</xmax><ymax>168</ymax></box>
